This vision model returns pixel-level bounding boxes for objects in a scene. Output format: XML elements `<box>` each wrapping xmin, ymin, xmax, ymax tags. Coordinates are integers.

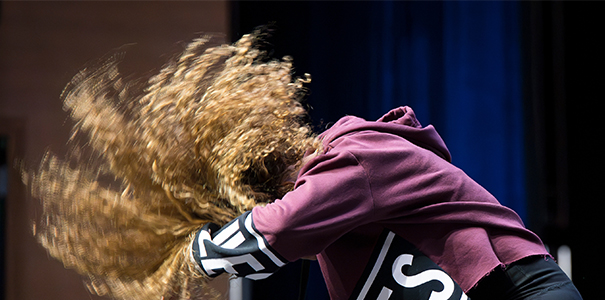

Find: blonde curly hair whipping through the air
<box><xmin>24</xmin><ymin>31</ymin><xmax>319</xmax><ymax>299</ymax></box>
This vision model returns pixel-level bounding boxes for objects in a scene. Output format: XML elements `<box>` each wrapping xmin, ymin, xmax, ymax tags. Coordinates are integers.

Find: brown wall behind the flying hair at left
<box><xmin>0</xmin><ymin>1</ymin><xmax>230</xmax><ymax>300</ymax></box>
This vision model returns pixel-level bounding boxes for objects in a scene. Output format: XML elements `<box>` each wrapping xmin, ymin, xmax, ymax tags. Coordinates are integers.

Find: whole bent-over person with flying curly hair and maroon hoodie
<box><xmin>23</xmin><ymin>29</ymin><xmax>579</xmax><ymax>300</ymax></box>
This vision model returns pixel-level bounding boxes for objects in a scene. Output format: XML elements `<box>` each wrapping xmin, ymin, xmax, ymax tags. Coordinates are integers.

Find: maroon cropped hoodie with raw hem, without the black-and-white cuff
<box><xmin>252</xmin><ymin>107</ymin><xmax>548</xmax><ymax>299</ymax></box>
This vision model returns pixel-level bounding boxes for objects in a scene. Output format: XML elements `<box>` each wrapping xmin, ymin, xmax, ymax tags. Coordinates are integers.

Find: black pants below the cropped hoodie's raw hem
<box><xmin>467</xmin><ymin>256</ymin><xmax>582</xmax><ymax>300</ymax></box>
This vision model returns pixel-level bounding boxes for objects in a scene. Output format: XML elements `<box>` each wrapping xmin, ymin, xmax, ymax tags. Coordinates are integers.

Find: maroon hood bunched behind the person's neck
<box><xmin>319</xmin><ymin>106</ymin><xmax>452</xmax><ymax>162</ymax></box>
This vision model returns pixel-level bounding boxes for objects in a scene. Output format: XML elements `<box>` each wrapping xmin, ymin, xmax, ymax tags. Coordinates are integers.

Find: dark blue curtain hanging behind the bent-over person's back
<box><xmin>302</xmin><ymin>1</ymin><xmax>526</xmax><ymax>218</ymax></box>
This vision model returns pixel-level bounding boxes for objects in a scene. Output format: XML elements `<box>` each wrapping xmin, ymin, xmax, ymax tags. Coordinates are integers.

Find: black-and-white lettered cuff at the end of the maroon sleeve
<box><xmin>192</xmin><ymin>212</ymin><xmax>287</xmax><ymax>280</ymax></box>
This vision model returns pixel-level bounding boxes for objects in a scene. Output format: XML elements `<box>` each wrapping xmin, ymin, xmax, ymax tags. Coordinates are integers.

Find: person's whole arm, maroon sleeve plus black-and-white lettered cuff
<box><xmin>191</xmin><ymin>151</ymin><xmax>374</xmax><ymax>280</ymax></box>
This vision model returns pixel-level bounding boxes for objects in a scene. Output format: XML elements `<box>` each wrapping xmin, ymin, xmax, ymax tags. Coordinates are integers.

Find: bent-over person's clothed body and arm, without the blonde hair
<box><xmin>192</xmin><ymin>107</ymin><xmax>581</xmax><ymax>300</ymax></box>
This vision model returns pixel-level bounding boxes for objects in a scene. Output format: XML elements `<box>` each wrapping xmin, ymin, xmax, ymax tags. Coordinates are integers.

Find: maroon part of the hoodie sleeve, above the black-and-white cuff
<box><xmin>252</xmin><ymin>151</ymin><xmax>374</xmax><ymax>261</ymax></box>
